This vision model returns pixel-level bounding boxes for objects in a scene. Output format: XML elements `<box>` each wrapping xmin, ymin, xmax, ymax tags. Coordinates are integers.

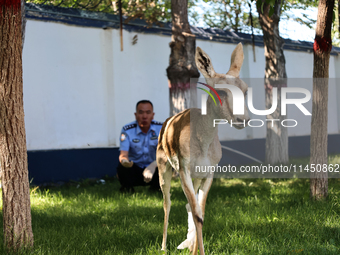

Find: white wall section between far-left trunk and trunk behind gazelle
<box><xmin>23</xmin><ymin>20</ymin><xmax>170</xmax><ymax>150</ymax></box>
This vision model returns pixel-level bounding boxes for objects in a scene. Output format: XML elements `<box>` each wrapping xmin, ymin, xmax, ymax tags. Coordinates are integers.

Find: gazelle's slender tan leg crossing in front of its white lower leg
<box><xmin>179</xmin><ymin>169</ymin><xmax>204</xmax><ymax>255</ymax></box>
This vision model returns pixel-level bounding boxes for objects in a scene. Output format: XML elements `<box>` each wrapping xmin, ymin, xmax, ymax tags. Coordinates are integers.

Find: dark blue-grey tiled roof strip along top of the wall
<box><xmin>25</xmin><ymin>3</ymin><xmax>340</xmax><ymax>55</ymax></box>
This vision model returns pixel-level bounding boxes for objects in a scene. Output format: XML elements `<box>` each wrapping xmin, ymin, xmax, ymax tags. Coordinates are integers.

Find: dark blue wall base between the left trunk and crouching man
<box><xmin>28</xmin><ymin>148</ymin><xmax>119</xmax><ymax>185</ymax></box>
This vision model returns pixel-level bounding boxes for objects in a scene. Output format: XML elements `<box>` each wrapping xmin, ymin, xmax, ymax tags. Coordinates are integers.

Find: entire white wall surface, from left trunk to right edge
<box><xmin>23</xmin><ymin>17</ymin><xmax>340</xmax><ymax>150</ymax></box>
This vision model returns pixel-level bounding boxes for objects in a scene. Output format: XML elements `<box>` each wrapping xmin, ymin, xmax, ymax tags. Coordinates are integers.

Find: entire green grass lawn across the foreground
<box><xmin>0</xmin><ymin>156</ymin><xmax>340</xmax><ymax>255</ymax></box>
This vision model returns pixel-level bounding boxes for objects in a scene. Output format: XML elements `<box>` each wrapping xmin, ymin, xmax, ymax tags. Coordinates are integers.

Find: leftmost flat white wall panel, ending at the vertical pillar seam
<box><xmin>23</xmin><ymin>20</ymin><xmax>108</xmax><ymax>150</ymax></box>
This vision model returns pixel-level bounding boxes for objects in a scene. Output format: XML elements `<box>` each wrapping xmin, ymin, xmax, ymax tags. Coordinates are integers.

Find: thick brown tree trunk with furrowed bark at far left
<box><xmin>0</xmin><ymin>0</ymin><xmax>33</xmax><ymax>250</ymax></box>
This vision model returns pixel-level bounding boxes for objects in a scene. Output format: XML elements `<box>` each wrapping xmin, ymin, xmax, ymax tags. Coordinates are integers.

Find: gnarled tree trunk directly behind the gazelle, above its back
<box><xmin>166</xmin><ymin>0</ymin><xmax>199</xmax><ymax>116</ymax></box>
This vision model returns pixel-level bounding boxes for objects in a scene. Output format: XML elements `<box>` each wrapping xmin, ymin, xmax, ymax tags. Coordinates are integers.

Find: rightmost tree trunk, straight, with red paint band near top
<box><xmin>310</xmin><ymin>0</ymin><xmax>334</xmax><ymax>200</ymax></box>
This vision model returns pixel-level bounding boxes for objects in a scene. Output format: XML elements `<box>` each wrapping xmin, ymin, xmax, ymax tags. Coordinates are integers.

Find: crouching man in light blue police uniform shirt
<box><xmin>117</xmin><ymin>100</ymin><xmax>163</xmax><ymax>192</ymax></box>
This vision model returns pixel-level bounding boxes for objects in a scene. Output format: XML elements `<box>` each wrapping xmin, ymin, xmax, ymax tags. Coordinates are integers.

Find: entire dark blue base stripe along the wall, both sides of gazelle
<box><xmin>28</xmin><ymin>134</ymin><xmax>340</xmax><ymax>185</ymax></box>
